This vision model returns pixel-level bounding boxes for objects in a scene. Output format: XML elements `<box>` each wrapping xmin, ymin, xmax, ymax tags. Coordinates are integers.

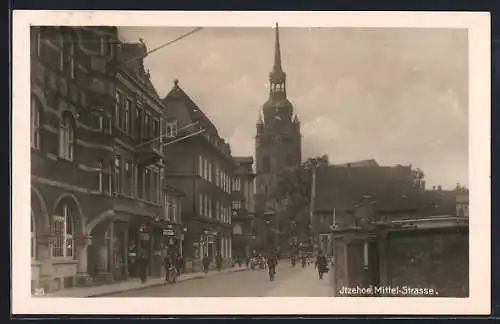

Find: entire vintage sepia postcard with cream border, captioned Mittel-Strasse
<box><xmin>12</xmin><ymin>11</ymin><xmax>490</xmax><ymax>315</ymax></box>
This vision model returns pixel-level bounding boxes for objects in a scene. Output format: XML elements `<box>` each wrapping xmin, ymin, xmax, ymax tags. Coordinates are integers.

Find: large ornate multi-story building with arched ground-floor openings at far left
<box><xmin>31</xmin><ymin>27</ymin><xmax>182</xmax><ymax>291</ymax></box>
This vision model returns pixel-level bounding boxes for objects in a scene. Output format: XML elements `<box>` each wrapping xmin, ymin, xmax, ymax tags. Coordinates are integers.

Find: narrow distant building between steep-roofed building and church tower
<box><xmin>232</xmin><ymin>156</ymin><xmax>255</xmax><ymax>260</ymax></box>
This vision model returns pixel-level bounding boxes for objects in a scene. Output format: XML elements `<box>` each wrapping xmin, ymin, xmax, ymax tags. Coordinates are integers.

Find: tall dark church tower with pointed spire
<box><xmin>255</xmin><ymin>24</ymin><xmax>302</xmax><ymax>204</ymax></box>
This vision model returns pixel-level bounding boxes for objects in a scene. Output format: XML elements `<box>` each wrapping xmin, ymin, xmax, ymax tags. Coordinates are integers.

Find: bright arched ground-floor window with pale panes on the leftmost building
<box><xmin>52</xmin><ymin>204</ymin><xmax>75</xmax><ymax>258</ymax></box>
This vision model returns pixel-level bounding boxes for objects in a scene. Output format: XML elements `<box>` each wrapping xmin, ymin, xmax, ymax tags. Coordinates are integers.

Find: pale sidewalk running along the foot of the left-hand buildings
<box><xmin>44</xmin><ymin>266</ymin><xmax>247</xmax><ymax>298</ymax></box>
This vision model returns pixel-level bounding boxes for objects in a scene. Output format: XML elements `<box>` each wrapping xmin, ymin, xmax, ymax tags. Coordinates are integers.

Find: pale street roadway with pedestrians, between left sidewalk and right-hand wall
<box><xmin>108</xmin><ymin>262</ymin><xmax>333</xmax><ymax>298</ymax></box>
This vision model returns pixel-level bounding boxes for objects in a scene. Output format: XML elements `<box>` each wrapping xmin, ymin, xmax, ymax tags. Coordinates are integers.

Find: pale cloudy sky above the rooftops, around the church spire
<box><xmin>120</xmin><ymin>27</ymin><xmax>468</xmax><ymax>188</ymax></box>
